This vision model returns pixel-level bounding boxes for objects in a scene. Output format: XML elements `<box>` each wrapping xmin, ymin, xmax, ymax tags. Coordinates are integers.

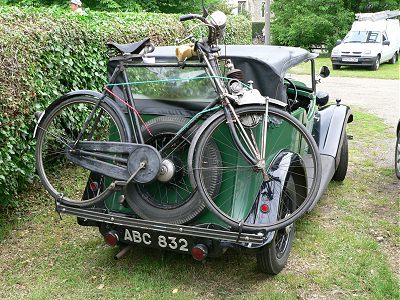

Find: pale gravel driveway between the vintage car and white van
<box><xmin>293</xmin><ymin>71</ymin><xmax>400</xmax><ymax>131</ymax></box>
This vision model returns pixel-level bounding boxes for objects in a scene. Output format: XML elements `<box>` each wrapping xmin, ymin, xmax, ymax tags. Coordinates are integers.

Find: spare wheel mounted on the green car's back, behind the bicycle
<box><xmin>125</xmin><ymin>116</ymin><xmax>219</xmax><ymax>224</ymax></box>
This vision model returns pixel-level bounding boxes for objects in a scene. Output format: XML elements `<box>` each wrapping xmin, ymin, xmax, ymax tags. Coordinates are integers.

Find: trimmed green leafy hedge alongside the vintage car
<box><xmin>0</xmin><ymin>6</ymin><xmax>251</xmax><ymax>207</ymax></box>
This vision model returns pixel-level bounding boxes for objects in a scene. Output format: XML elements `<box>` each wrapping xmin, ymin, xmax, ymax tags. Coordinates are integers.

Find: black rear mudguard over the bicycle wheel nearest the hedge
<box><xmin>33</xmin><ymin>90</ymin><xmax>132</xmax><ymax>142</ymax></box>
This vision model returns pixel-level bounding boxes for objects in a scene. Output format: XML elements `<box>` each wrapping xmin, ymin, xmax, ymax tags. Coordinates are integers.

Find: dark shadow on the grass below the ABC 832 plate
<box><xmin>84</xmin><ymin>240</ymin><xmax>273</xmax><ymax>298</ymax></box>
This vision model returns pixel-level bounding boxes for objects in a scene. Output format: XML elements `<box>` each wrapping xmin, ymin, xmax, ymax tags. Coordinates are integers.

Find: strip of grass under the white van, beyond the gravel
<box><xmin>290</xmin><ymin>56</ymin><xmax>400</xmax><ymax>80</ymax></box>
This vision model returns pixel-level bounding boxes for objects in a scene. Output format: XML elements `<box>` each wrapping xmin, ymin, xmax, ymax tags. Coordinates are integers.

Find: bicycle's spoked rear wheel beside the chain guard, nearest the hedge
<box><xmin>35</xmin><ymin>96</ymin><xmax>127</xmax><ymax>206</ymax></box>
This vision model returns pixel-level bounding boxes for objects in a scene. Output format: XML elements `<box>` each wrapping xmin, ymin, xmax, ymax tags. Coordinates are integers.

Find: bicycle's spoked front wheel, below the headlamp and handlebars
<box><xmin>189</xmin><ymin>106</ymin><xmax>321</xmax><ymax>231</ymax></box>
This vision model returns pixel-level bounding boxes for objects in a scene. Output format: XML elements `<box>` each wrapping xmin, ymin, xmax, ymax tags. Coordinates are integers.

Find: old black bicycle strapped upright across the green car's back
<box><xmin>35</xmin><ymin>9</ymin><xmax>321</xmax><ymax>232</ymax></box>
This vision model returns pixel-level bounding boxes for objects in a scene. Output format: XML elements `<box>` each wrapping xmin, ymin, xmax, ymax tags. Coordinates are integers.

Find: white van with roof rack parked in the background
<box><xmin>331</xmin><ymin>10</ymin><xmax>400</xmax><ymax>70</ymax></box>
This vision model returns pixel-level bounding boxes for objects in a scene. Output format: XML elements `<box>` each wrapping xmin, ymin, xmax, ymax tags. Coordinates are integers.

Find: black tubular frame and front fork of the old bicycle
<box><xmin>74</xmin><ymin>44</ymin><xmax>268</xmax><ymax>173</ymax></box>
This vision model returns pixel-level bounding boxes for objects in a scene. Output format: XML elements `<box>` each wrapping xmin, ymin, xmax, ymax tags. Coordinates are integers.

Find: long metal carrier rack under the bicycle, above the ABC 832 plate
<box><xmin>56</xmin><ymin>201</ymin><xmax>269</xmax><ymax>245</ymax></box>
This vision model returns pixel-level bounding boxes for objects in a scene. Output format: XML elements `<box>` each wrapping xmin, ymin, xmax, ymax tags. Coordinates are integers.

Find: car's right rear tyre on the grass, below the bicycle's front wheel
<box><xmin>256</xmin><ymin>176</ymin><xmax>297</xmax><ymax>275</ymax></box>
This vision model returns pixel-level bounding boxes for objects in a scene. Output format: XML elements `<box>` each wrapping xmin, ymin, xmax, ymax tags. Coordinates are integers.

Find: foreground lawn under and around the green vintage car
<box><xmin>0</xmin><ymin>112</ymin><xmax>400</xmax><ymax>299</ymax></box>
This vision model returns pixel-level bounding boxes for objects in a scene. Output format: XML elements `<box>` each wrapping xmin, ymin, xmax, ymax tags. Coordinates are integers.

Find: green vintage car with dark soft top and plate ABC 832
<box><xmin>35</xmin><ymin>45</ymin><xmax>353</xmax><ymax>274</ymax></box>
